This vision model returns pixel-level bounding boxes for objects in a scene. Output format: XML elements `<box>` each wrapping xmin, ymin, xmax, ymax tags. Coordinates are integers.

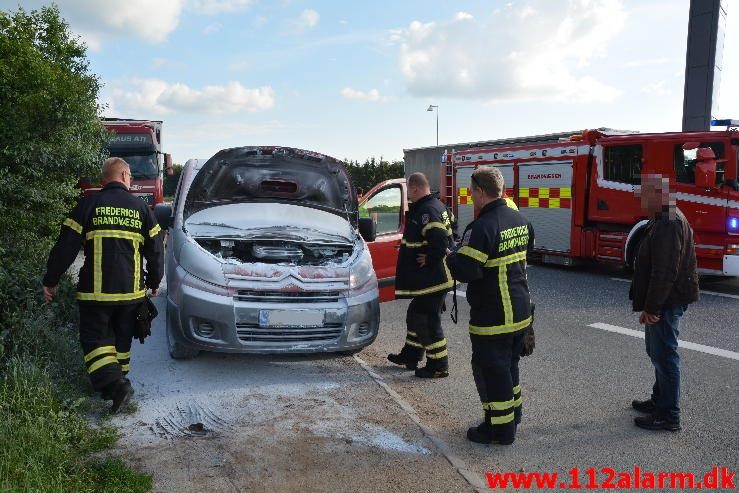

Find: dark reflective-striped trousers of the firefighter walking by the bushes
<box><xmin>79</xmin><ymin>303</ymin><xmax>139</xmax><ymax>392</ymax></box>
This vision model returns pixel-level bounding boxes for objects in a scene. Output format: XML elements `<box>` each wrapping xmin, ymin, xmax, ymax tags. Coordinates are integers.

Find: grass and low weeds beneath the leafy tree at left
<box><xmin>0</xmin><ymin>274</ymin><xmax>152</xmax><ymax>492</ymax></box>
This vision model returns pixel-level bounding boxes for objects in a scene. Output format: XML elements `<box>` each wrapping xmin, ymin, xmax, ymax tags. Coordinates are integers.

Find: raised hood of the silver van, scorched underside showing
<box><xmin>184</xmin><ymin>147</ymin><xmax>358</xmax><ymax>227</ymax></box>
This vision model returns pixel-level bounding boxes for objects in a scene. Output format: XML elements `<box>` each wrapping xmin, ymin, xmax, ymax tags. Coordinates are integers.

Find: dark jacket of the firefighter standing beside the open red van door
<box><xmin>395</xmin><ymin>194</ymin><xmax>454</xmax><ymax>298</ymax></box>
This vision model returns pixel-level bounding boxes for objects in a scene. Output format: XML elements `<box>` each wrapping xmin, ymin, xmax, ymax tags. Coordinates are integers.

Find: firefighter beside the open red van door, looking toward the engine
<box><xmin>387</xmin><ymin>173</ymin><xmax>454</xmax><ymax>378</ymax></box>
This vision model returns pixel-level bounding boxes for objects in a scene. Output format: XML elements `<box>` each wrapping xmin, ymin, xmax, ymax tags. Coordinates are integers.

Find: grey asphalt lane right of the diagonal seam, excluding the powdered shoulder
<box><xmin>360</xmin><ymin>266</ymin><xmax>739</xmax><ymax>486</ymax></box>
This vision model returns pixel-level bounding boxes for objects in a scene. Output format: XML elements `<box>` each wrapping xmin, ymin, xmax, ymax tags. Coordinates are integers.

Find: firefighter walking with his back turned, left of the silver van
<box><xmin>43</xmin><ymin>158</ymin><xmax>164</xmax><ymax>412</ymax></box>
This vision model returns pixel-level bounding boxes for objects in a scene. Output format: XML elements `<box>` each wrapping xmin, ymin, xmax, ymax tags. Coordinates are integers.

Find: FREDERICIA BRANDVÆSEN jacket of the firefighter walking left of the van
<box><xmin>43</xmin><ymin>182</ymin><xmax>164</xmax><ymax>305</ymax></box>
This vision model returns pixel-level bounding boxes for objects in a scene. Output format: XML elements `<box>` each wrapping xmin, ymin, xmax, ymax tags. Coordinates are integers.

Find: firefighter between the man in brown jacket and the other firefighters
<box><xmin>447</xmin><ymin>168</ymin><xmax>534</xmax><ymax>445</ymax></box>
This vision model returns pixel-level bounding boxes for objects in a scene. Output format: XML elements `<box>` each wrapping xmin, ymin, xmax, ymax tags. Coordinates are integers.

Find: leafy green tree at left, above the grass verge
<box><xmin>0</xmin><ymin>6</ymin><xmax>108</xmax><ymax>322</ymax></box>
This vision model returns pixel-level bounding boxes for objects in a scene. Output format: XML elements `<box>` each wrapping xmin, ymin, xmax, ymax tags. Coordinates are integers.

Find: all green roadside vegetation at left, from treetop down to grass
<box><xmin>0</xmin><ymin>6</ymin><xmax>152</xmax><ymax>492</ymax></box>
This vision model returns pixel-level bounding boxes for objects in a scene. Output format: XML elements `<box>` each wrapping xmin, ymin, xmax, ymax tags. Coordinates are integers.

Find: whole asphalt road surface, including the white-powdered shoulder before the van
<box><xmin>107</xmin><ymin>266</ymin><xmax>739</xmax><ymax>491</ymax></box>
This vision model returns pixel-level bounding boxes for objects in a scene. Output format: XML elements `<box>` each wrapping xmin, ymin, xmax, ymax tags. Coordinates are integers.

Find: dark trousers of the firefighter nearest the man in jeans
<box><xmin>470</xmin><ymin>331</ymin><xmax>523</xmax><ymax>441</ymax></box>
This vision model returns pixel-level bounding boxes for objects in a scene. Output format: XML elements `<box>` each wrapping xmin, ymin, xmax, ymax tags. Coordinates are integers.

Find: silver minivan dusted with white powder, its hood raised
<box><xmin>155</xmin><ymin>147</ymin><xmax>380</xmax><ymax>359</ymax></box>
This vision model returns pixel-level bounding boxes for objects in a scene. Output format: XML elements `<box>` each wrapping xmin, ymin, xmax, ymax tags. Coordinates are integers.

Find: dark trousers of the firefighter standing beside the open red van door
<box><xmin>403</xmin><ymin>291</ymin><xmax>449</xmax><ymax>369</ymax></box>
